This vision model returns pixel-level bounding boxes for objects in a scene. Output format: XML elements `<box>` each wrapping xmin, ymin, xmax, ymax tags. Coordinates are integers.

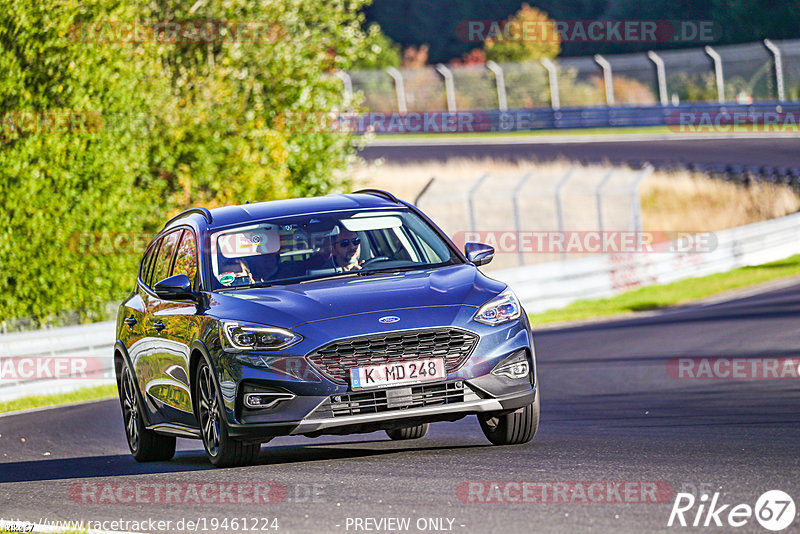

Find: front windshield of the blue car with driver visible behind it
<box><xmin>211</xmin><ymin>210</ymin><xmax>461</xmax><ymax>290</ymax></box>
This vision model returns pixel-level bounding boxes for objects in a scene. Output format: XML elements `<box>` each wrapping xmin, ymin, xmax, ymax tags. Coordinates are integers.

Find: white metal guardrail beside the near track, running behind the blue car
<box><xmin>0</xmin><ymin>213</ymin><xmax>800</xmax><ymax>401</ymax></box>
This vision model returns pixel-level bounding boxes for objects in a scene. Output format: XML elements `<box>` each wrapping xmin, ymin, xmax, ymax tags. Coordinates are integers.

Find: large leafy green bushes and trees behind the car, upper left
<box><xmin>0</xmin><ymin>0</ymin><xmax>391</xmax><ymax>323</ymax></box>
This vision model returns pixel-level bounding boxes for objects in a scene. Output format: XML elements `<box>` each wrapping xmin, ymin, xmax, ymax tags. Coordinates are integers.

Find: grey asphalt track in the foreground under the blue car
<box><xmin>0</xmin><ymin>285</ymin><xmax>800</xmax><ymax>534</ymax></box>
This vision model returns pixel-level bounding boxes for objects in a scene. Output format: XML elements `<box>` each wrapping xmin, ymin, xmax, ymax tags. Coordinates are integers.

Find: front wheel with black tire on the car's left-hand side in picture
<box><xmin>195</xmin><ymin>360</ymin><xmax>261</xmax><ymax>467</ymax></box>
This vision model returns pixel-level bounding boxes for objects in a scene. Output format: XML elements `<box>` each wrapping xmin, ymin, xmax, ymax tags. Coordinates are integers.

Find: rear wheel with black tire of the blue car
<box><xmin>119</xmin><ymin>362</ymin><xmax>175</xmax><ymax>462</ymax></box>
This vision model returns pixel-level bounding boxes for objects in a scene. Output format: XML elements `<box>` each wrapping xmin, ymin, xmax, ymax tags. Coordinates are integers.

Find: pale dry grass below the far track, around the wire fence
<box><xmin>353</xmin><ymin>159</ymin><xmax>800</xmax><ymax>231</ymax></box>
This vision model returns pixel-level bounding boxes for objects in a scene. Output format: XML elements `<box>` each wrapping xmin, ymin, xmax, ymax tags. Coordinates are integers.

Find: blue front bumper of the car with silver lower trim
<box><xmin>212</xmin><ymin>312</ymin><xmax>537</xmax><ymax>441</ymax></box>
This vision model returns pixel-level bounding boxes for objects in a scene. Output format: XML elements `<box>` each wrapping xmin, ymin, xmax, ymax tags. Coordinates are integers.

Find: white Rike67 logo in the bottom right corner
<box><xmin>667</xmin><ymin>490</ymin><xmax>797</xmax><ymax>532</ymax></box>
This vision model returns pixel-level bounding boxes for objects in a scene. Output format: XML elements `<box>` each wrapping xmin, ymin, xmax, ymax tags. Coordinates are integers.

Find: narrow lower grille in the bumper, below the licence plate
<box><xmin>330</xmin><ymin>382</ymin><xmax>464</xmax><ymax>417</ymax></box>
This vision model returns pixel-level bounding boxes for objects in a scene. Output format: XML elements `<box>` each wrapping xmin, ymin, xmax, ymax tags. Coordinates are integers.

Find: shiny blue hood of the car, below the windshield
<box><xmin>208</xmin><ymin>264</ymin><xmax>505</xmax><ymax>328</ymax></box>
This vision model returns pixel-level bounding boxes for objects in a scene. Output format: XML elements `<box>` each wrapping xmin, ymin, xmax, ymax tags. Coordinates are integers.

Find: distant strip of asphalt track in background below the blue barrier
<box><xmin>361</xmin><ymin>135</ymin><xmax>800</xmax><ymax>167</ymax></box>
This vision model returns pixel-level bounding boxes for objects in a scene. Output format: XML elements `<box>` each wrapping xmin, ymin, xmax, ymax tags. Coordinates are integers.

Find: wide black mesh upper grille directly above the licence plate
<box><xmin>308</xmin><ymin>328</ymin><xmax>478</xmax><ymax>384</ymax></box>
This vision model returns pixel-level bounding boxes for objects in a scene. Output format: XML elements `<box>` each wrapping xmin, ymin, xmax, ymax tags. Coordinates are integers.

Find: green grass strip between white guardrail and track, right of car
<box><xmin>530</xmin><ymin>255</ymin><xmax>800</xmax><ymax>325</ymax></box>
